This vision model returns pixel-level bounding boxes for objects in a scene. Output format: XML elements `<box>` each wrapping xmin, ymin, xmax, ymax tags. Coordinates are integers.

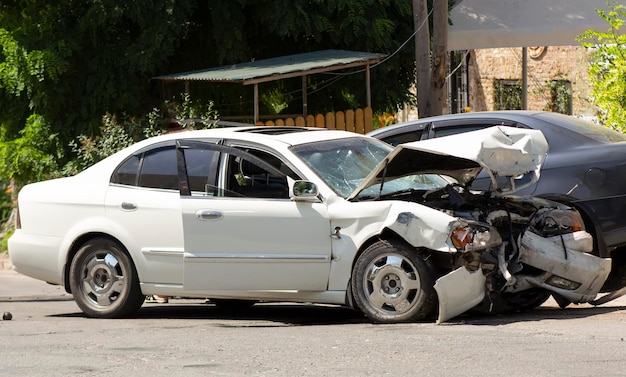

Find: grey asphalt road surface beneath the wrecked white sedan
<box><xmin>0</xmin><ymin>264</ymin><xmax>626</xmax><ymax>376</ymax></box>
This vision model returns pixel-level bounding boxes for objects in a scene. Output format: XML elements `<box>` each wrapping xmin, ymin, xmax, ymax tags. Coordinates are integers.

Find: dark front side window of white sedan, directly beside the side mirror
<box><xmin>226</xmin><ymin>150</ymin><xmax>297</xmax><ymax>199</ymax></box>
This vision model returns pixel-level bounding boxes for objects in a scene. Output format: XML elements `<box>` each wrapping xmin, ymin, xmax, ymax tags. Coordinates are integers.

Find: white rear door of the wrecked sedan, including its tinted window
<box><xmin>105</xmin><ymin>143</ymin><xmax>183</xmax><ymax>285</ymax></box>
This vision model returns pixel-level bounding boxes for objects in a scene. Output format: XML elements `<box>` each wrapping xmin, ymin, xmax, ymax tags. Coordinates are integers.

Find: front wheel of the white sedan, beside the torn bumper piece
<box><xmin>352</xmin><ymin>241</ymin><xmax>437</xmax><ymax>323</ymax></box>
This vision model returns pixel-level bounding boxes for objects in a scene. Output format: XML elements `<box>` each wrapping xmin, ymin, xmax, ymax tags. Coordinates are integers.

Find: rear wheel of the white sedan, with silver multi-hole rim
<box><xmin>70</xmin><ymin>238</ymin><xmax>145</xmax><ymax>318</ymax></box>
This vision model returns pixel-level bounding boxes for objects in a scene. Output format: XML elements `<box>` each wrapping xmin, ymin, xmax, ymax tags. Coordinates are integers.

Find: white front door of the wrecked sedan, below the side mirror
<box><xmin>179</xmin><ymin>143</ymin><xmax>331</xmax><ymax>292</ymax></box>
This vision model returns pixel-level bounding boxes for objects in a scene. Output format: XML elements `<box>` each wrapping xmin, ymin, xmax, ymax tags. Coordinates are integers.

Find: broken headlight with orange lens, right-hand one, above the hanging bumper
<box><xmin>532</xmin><ymin>208</ymin><xmax>585</xmax><ymax>237</ymax></box>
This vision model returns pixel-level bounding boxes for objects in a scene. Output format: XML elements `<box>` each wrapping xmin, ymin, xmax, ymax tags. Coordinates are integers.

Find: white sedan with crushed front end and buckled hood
<box><xmin>9</xmin><ymin>127</ymin><xmax>611</xmax><ymax>323</ymax></box>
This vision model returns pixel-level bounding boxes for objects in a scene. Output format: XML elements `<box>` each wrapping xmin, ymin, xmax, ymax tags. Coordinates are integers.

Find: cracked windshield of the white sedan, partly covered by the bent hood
<box><xmin>292</xmin><ymin>137</ymin><xmax>450</xmax><ymax>199</ymax></box>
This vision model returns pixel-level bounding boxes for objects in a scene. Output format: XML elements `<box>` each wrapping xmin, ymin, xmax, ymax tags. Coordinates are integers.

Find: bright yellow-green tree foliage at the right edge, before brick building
<box><xmin>578</xmin><ymin>2</ymin><xmax>626</xmax><ymax>132</ymax></box>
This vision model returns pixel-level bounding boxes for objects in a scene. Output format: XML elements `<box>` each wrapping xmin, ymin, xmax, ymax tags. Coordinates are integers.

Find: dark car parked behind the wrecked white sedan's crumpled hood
<box><xmin>369</xmin><ymin>110</ymin><xmax>626</xmax><ymax>290</ymax></box>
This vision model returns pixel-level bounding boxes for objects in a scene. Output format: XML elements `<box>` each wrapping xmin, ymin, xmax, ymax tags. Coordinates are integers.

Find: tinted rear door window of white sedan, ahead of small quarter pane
<box><xmin>138</xmin><ymin>147</ymin><xmax>178</xmax><ymax>190</ymax></box>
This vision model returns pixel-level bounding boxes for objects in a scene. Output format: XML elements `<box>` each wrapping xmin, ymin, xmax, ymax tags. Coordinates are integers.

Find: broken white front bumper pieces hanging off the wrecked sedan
<box><xmin>435</xmin><ymin>231</ymin><xmax>611</xmax><ymax>323</ymax></box>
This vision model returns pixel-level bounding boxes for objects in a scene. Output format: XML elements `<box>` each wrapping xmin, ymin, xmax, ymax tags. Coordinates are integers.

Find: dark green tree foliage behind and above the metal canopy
<box><xmin>0</xmin><ymin>0</ymin><xmax>414</xmax><ymax>141</ymax></box>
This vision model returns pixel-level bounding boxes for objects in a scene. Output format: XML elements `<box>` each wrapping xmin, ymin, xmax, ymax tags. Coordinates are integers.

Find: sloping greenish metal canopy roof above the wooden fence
<box><xmin>155</xmin><ymin>50</ymin><xmax>385</xmax><ymax>85</ymax></box>
